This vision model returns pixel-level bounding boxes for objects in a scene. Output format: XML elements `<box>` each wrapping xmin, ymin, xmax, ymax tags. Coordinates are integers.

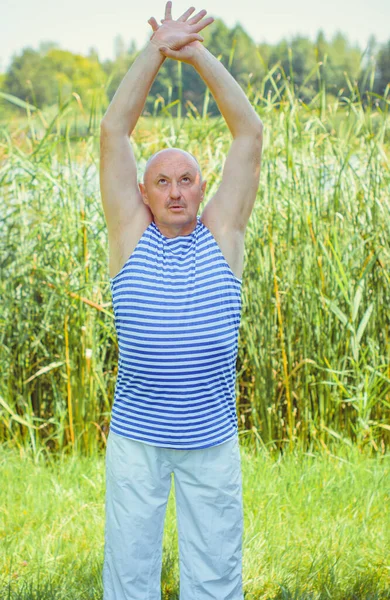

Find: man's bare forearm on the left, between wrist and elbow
<box><xmin>101</xmin><ymin>42</ymin><xmax>165</xmax><ymax>136</ymax></box>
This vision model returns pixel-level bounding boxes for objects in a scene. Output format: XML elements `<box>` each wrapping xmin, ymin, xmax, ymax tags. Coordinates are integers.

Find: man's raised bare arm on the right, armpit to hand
<box><xmin>160</xmin><ymin>34</ymin><xmax>263</xmax><ymax>233</ymax></box>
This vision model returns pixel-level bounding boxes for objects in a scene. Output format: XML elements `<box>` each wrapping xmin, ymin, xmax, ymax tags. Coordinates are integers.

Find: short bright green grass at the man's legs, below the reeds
<box><xmin>0</xmin><ymin>440</ymin><xmax>390</xmax><ymax>600</ymax></box>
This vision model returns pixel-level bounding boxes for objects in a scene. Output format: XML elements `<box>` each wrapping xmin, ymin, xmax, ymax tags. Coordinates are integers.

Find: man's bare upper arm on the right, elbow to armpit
<box><xmin>202</xmin><ymin>128</ymin><xmax>263</xmax><ymax>232</ymax></box>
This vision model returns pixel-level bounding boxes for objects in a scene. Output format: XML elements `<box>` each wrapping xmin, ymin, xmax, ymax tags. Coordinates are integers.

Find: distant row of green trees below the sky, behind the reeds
<box><xmin>0</xmin><ymin>19</ymin><xmax>390</xmax><ymax>119</ymax></box>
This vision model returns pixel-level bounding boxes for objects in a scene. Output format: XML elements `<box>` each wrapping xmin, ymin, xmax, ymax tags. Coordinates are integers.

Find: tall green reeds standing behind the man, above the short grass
<box><xmin>0</xmin><ymin>56</ymin><xmax>390</xmax><ymax>454</ymax></box>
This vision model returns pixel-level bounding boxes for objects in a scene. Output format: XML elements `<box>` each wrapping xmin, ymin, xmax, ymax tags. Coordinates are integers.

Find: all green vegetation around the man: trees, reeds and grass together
<box><xmin>0</xmin><ymin>21</ymin><xmax>390</xmax><ymax>600</ymax></box>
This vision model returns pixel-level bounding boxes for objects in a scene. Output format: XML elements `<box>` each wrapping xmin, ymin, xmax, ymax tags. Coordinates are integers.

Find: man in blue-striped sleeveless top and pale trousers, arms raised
<box><xmin>100</xmin><ymin>2</ymin><xmax>263</xmax><ymax>600</ymax></box>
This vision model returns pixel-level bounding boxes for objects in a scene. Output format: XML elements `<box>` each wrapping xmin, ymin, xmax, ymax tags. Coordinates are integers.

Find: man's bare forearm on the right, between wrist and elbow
<box><xmin>191</xmin><ymin>44</ymin><xmax>263</xmax><ymax>137</ymax></box>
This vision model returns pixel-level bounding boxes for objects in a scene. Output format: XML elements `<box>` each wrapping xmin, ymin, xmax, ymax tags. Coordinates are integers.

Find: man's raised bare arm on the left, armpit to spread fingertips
<box><xmin>100</xmin><ymin>2</ymin><xmax>213</xmax><ymax>240</ymax></box>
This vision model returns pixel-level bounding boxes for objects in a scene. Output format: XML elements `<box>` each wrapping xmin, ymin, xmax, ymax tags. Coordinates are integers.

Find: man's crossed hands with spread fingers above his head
<box><xmin>148</xmin><ymin>1</ymin><xmax>214</xmax><ymax>63</ymax></box>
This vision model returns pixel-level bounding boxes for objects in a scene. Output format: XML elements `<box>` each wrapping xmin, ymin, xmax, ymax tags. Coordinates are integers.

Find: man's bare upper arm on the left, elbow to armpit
<box><xmin>100</xmin><ymin>126</ymin><xmax>148</xmax><ymax>236</ymax></box>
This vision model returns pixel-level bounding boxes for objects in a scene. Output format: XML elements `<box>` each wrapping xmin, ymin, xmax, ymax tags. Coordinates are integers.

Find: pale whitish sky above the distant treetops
<box><xmin>0</xmin><ymin>0</ymin><xmax>390</xmax><ymax>73</ymax></box>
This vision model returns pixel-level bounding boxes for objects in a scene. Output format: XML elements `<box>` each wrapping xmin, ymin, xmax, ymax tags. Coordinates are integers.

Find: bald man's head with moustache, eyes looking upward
<box><xmin>139</xmin><ymin>148</ymin><xmax>207</xmax><ymax>235</ymax></box>
